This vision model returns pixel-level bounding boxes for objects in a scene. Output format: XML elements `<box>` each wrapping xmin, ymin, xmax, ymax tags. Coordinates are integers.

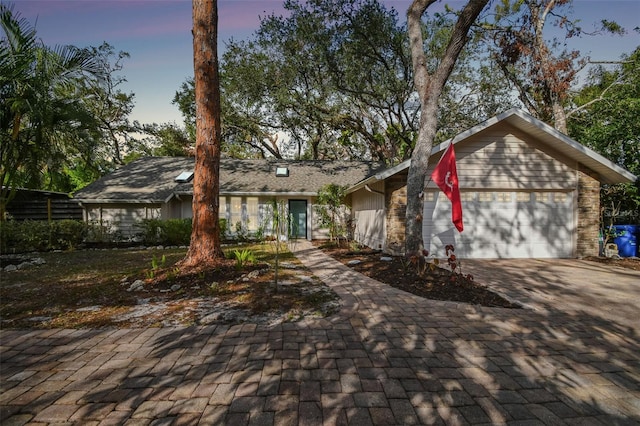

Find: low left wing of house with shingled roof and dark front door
<box><xmin>75</xmin><ymin>157</ymin><xmax>381</xmax><ymax>239</ymax></box>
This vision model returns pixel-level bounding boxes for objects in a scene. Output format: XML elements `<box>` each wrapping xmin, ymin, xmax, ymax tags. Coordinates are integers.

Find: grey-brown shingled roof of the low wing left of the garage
<box><xmin>75</xmin><ymin>157</ymin><xmax>381</xmax><ymax>203</ymax></box>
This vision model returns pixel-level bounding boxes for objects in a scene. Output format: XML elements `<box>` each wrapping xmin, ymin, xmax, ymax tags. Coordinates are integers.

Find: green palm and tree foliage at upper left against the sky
<box><xmin>0</xmin><ymin>2</ymin><xmax>146</xmax><ymax>201</ymax></box>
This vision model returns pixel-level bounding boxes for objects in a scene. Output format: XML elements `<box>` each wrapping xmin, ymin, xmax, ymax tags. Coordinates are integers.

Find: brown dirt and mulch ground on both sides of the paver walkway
<box><xmin>0</xmin><ymin>244</ymin><xmax>640</xmax><ymax>328</ymax></box>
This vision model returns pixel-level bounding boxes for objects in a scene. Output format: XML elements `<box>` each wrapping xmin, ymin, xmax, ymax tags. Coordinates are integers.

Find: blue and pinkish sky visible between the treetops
<box><xmin>10</xmin><ymin>0</ymin><xmax>640</xmax><ymax>124</ymax></box>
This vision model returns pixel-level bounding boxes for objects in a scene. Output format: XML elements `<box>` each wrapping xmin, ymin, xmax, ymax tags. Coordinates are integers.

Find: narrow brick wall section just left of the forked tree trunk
<box><xmin>385</xmin><ymin>173</ymin><xmax>407</xmax><ymax>255</ymax></box>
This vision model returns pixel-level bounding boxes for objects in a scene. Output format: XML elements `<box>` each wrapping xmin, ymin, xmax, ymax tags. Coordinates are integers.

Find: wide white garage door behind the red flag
<box><xmin>423</xmin><ymin>191</ymin><xmax>574</xmax><ymax>258</ymax></box>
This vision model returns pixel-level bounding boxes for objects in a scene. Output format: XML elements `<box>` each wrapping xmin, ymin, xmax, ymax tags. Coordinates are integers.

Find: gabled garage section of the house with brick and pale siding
<box><xmin>348</xmin><ymin>109</ymin><xmax>637</xmax><ymax>258</ymax></box>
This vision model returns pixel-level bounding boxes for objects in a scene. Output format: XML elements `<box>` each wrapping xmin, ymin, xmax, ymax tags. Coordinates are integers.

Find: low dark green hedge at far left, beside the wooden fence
<box><xmin>0</xmin><ymin>220</ymin><xmax>88</xmax><ymax>253</ymax></box>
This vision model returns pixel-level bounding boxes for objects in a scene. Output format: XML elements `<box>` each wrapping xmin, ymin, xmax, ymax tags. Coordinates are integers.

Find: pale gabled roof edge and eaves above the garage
<box><xmin>348</xmin><ymin>108</ymin><xmax>637</xmax><ymax>192</ymax></box>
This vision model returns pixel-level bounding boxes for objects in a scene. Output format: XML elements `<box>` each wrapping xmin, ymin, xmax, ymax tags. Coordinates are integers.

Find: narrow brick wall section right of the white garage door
<box><xmin>576</xmin><ymin>166</ymin><xmax>600</xmax><ymax>257</ymax></box>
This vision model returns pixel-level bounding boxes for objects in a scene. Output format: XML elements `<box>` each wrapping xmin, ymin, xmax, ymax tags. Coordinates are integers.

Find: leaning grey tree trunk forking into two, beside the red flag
<box><xmin>405</xmin><ymin>0</ymin><xmax>489</xmax><ymax>255</ymax></box>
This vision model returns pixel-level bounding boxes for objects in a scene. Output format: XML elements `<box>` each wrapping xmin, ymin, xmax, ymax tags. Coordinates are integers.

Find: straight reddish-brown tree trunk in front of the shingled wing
<box><xmin>181</xmin><ymin>0</ymin><xmax>224</xmax><ymax>267</ymax></box>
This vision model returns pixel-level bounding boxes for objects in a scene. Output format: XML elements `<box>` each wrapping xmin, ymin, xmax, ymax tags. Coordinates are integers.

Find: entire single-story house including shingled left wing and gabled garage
<box><xmin>75</xmin><ymin>109</ymin><xmax>636</xmax><ymax>258</ymax></box>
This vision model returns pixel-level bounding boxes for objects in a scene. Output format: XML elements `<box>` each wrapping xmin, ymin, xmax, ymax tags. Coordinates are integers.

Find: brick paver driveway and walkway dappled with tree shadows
<box><xmin>0</xmin><ymin>243</ymin><xmax>640</xmax><ymax>425</ymax></box>
